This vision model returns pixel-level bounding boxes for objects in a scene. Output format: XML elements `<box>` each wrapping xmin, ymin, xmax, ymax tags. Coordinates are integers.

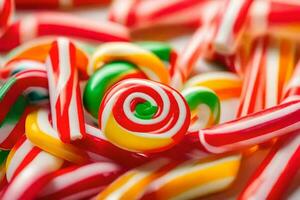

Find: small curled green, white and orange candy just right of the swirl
<box><xmin>181</xmin><ymin>86</ymin><xmax>220</xmax><ymax>133</ymax></box>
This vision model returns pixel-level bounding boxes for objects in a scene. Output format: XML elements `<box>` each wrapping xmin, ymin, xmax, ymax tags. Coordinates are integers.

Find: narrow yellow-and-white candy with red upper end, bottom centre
<box><xmin>95</xmin><ymin>158</ymin><xmax>176</xmax><ymax>200</ymax></box>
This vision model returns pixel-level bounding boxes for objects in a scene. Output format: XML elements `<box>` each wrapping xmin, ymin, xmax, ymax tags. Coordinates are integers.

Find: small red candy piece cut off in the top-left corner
<box><xmin>0</xmin><ymin>0</ymin><xmax>14</xmax><ymax>36</ymax></box>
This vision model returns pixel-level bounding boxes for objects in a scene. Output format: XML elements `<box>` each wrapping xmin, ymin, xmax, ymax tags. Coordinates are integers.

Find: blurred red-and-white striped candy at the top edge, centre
<box><xmin>109</xmin><ymin>0</ymin><xmax>219</xmax><ymax>29</ymax></box>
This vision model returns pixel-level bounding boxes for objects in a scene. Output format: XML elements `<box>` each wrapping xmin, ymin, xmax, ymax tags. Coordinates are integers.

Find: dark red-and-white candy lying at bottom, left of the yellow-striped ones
<box><xmin>38</xmin><ymin>162</ymin><xmax>123</xmax><ymax>199</ymax></box>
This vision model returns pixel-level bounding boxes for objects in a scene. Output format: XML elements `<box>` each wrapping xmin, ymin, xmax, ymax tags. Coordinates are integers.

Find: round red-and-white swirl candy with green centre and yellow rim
<box><xmin>98</xmin><ymin>79</ymin><xmax>190</xmax><ymax>152</ymax></box>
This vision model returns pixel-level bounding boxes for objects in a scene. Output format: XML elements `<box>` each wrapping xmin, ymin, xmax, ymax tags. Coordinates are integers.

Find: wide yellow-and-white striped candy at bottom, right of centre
<box><xmin>141</xmin><ymin>155</ymin><xmax>241</xmax><ymax>199</ymax></box>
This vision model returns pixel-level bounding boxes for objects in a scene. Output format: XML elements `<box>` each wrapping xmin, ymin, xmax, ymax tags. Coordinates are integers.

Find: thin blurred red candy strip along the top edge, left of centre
<box><xmin>15</xmin><ymin>0</ymin><xmax>108</xmax><ymax>9</ymax></box>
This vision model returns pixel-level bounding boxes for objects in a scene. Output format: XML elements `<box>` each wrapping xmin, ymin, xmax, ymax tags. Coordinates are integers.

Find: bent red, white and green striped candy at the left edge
<box><xmin>0</xmin><ymin>70</ymin><xmax>48</xmax><ymax>149</ymax></box>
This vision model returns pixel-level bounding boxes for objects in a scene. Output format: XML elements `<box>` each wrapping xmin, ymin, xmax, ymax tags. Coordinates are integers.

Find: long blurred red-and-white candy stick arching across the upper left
<box><xmin>0</xmin><ymin>12</ymin><xmax>129</xmax><ymax>51</ymax></box>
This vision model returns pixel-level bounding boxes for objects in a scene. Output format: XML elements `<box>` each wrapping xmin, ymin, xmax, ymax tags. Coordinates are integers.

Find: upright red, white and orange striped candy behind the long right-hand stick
<box><xmin>238</xmin><ymin>38</ymin><xmax>296</xmax><ymax>116</ymax></box>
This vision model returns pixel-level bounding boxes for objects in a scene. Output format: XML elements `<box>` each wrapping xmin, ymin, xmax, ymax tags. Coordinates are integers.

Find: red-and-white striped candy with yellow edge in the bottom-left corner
<box><xmin>1</xmin><ymin>137</ymin><xmax>63</xmax><ymax>199</ymax></box>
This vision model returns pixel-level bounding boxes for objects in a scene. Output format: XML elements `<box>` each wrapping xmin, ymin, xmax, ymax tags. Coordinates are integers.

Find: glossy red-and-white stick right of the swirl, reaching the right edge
<box><xmin>192</xmin><ymin>100</ymin><xmax>300</xmax><ymax>153</ymax></box>
